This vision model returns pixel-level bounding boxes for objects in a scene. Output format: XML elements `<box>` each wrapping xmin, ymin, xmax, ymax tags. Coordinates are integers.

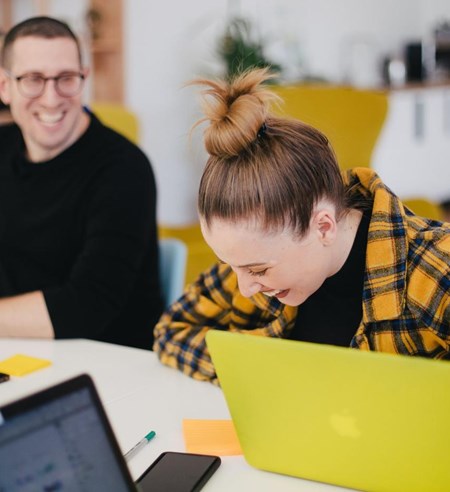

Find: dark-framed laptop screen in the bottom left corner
<box><xmin>0</xmin><ymin>375</ymin><xmax>136</xmax><ymax>492</ymax></box>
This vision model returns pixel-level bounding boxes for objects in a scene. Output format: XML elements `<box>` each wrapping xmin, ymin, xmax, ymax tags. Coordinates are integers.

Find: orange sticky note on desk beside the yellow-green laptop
<box><xmin>183</xmin><ymin>419</ymin><xmax>242</xmax><ymax>456</ymax></box>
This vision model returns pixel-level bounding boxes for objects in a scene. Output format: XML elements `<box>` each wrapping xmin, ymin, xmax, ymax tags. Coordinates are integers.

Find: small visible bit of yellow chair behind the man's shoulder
<box><xmin>90</xmin><ymin>102</ymin><xmax>139</xmax><ymax>144</ymax></box>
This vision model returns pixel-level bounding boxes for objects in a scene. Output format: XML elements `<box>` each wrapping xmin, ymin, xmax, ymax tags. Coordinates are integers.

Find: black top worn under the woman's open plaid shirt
<box><xmin>290</xmin><ymin>213</ymin><xmax>370</xmax><ymax>347</ymax></box>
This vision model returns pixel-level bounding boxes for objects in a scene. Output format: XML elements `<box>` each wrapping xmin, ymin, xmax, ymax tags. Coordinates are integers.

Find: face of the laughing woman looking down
<box><xmin>202</xmin><ymin>214</ymin><xmax>342</xmax><ymax>306</ymax></box>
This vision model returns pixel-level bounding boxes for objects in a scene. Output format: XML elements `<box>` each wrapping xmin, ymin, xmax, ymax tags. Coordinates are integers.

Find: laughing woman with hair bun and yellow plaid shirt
<box><xmin>154</xmin><ymin>69</ymin><xmax>450</xmax><ymax>383</ymax></box>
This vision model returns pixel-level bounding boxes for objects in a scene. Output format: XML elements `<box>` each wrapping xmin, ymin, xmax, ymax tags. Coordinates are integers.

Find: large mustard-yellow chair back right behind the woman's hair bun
<box><xmin>273</xmin><ymin>84</ymin><xmax>388</xmax><ymax>169</ymax></box>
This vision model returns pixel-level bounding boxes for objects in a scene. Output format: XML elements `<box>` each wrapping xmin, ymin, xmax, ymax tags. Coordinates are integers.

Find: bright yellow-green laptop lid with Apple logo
<box><xmin>206</xmin><ymin>330</ymin><xmax>450</xmax><ymax>492</ymax></box>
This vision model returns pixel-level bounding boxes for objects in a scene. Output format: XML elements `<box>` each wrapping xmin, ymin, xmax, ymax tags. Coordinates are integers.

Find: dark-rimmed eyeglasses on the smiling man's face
<box><xmin>5</xmin><ymin>71</ymin><xmax>85</xmax><ymax>99</ymax></box>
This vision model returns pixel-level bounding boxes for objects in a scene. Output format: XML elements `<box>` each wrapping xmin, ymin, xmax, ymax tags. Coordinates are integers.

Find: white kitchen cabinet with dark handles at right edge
<box><xmin>372</xmin><ymin>87</ymin><xmax>450</xmax><ymax>203</ymax></box>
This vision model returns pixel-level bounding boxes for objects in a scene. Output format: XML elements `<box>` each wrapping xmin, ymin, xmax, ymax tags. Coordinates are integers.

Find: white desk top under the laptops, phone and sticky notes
<box><xmin>0</xmin><ymin>339</ymin><xmax>345</xmax><ymax>492</ymax></box>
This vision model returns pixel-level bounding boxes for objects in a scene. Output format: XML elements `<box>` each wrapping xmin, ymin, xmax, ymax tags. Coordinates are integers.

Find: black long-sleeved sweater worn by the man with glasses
<box><xmin>0</xmin><ymin>111</ymin><xmax>162</xmax><ymax>349</ymax></box>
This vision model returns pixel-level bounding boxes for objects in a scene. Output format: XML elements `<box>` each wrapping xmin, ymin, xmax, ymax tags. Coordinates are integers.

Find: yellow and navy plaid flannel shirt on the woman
<box><xmin>153</xmin><ymin>168</ymin><xmax>450</xmax><ymax>384</ymax></box>
